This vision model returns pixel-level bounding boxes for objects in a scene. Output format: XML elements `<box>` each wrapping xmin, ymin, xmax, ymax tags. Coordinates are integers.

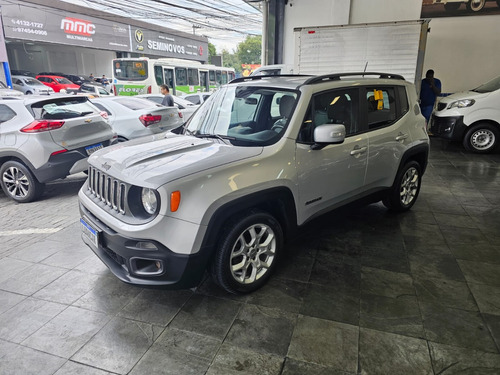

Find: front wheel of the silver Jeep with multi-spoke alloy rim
<box><xmin>211</xmin><ymin>211</ymin><xmax>283</xmax><ymax>294</ymax></box>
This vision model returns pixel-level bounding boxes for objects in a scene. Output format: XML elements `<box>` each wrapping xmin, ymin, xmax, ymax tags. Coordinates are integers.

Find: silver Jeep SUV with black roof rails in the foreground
<box><xmin>79</xmin><ymin>73</ymin><xmax>429</xmax><ymax>293</ymax></box>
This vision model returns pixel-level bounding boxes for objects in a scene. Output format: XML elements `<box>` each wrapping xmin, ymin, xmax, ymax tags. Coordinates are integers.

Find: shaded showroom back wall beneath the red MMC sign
<box><xmin>7</xmin><ymin>43</ymin><xmax>116</xmax><ymax>77</ymax></box>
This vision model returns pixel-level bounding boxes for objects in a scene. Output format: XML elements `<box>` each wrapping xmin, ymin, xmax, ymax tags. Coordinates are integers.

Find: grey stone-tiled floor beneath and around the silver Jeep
<box><xmin>0</xmin><ymin>140</ymin><xmax>500</xmax><ymax>375</ymax></box>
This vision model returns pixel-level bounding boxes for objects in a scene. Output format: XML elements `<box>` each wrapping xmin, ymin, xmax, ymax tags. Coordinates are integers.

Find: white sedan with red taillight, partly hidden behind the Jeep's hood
<box><xmin>90</xmin><ymin>96</ymin><xmax>183</xmax><ymax>142</ymax></box>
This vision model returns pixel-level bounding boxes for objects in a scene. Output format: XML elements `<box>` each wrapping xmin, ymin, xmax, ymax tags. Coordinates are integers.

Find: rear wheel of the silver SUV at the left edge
<box><xmin>0</xmin><ymin>160</ymin><xmax>44</xmax><ymax>203</ymax></box>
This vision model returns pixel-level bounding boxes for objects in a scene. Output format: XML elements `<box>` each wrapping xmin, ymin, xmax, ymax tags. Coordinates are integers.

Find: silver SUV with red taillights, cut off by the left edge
<box><xmin>0</xmin><ymin>95</ymin><xmax>114</xmax><ymax>203</ymax></box>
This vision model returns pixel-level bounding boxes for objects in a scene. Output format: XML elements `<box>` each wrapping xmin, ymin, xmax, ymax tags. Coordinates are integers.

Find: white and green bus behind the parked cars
<box><xmin>112</xmin><ymin>57</ymin><xmax>235</xmax><ymax>96</ymax></box>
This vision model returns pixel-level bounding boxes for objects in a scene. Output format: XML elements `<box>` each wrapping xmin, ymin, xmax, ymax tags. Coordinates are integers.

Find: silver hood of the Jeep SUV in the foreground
<box><xmin>89</xmin><ymin>132</ymin><xmax>263</xmax><ymax>188</ymax></box>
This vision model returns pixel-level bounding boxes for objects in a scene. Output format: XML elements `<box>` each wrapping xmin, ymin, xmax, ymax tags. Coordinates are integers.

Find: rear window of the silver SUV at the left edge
<box><xmin>31</xmin><ymin>97</ymin><xmax>99</xmax><ymax>119</ymax></box>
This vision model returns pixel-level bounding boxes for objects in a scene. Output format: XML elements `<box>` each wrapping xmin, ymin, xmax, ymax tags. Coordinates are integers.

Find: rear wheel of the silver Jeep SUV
<box><xmin>382</xmin><ymin>160</ymin><xmax>422</xmax><ymax>212</ymax></box>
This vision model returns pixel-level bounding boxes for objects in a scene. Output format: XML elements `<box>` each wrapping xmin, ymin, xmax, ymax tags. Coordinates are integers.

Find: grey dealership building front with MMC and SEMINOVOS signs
<box><xmin>0</xmin><ymin>0</ymin><xmax>208</xmax><ymax>82</ymax></box>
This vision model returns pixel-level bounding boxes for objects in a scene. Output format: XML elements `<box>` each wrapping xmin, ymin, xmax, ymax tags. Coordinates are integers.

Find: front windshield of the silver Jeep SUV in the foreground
<box><xmin>186</xmin><ymin>85</ymin><xmax>298</xmax><ymax>146</ymax></box>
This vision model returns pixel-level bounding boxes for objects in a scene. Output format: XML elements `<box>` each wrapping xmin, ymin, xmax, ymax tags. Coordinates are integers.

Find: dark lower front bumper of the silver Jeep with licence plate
<box><xmin>80</xmin><ymin>203</ymin><xmax>210</xmax><ymax>289</ymax></box>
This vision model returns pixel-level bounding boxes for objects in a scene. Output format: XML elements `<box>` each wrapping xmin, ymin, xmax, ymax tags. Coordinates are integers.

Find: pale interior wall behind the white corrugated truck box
<box><xmin>284</xmin><ymin>0</ymin><xmax>500</xmax><ymax>92</ymax></box>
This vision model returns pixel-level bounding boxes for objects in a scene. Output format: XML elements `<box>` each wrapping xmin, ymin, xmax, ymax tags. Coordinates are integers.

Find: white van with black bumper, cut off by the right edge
<box><xmin>430</xmin><ymin>76</ymin><xmax>500</xmax><ymax>153</ymax></box>
